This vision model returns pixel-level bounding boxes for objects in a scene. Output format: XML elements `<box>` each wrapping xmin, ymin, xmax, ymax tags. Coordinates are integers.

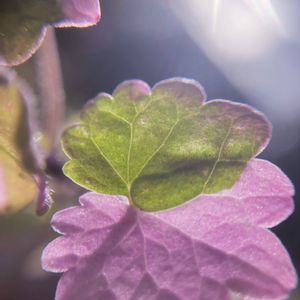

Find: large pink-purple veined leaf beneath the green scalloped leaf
<box><xmin>42</xmin><ymin>159</ymin><xmax>297</xmax><ymax>300</ymax></box>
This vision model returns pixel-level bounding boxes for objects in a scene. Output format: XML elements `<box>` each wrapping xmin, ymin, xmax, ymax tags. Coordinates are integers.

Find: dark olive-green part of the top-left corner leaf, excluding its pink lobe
<box><xmin>0</xmin><ymin>0</ymin><xmax>59</xmax><ymax>64</ymax></box>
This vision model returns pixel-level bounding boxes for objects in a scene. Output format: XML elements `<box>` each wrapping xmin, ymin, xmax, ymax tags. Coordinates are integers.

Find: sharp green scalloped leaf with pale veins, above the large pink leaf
<box><xmin>62</xmin><ymin>78</ymin><xmax>271</xmax><ymax>211</ymax></box>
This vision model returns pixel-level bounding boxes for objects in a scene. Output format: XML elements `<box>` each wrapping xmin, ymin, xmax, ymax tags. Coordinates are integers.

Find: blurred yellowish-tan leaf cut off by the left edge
<box><xmin>0</xmin><ymin>68</ymin><xmax>39</xmax><ymax>213</ymax></box>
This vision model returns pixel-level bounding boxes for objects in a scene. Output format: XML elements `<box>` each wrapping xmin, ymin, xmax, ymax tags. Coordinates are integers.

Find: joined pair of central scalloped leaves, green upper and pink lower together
<box><xmin>42</xmin><ymin>78</ymin><xmax>297</xmax><ymax>300</ymax></box>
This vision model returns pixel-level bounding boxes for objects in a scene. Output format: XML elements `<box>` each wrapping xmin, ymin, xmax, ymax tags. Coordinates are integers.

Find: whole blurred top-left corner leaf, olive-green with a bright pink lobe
<box><xmin>0</xmin><ymin>0</ymin><xmax>100</xmax><ymax>65</ymax></box>
